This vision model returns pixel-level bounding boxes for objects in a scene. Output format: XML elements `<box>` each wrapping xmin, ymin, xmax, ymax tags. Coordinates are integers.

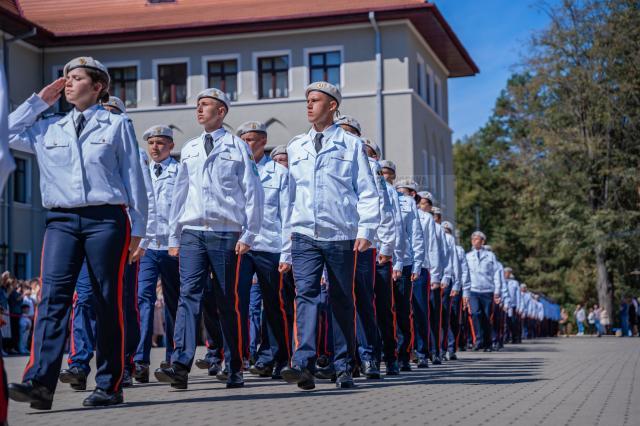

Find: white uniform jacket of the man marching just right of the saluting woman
<box><xmin>169</xmin><ymin>129</ymin><xmax>264</xmax><ymax>247</ymax></box>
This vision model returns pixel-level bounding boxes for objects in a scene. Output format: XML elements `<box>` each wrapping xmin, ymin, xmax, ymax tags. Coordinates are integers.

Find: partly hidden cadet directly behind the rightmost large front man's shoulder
<box><xmin>335</xmin><ymin>115</ymin><xmax>395</xmax><ymax>379</ymax></box>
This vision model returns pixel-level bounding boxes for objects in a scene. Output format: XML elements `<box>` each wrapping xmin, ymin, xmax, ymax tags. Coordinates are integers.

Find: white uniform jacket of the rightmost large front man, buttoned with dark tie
<box><xmin>287</xmin><ymin>125</ymin><xmax>380</xmax><ymax>243</ymax></box>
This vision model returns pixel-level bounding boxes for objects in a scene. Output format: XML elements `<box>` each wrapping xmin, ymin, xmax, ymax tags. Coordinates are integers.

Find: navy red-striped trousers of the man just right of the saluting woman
<box><xmin>171</xmin><ymin>229</ymin><xmax>244</xmax><ymax>373</ymax></box>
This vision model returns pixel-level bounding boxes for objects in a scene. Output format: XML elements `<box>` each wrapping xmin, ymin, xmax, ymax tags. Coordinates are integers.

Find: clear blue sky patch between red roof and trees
<box><xmin>432</xmin><ymin>0</ymin><xmax>557</xmax><ymax>141</ymax></box>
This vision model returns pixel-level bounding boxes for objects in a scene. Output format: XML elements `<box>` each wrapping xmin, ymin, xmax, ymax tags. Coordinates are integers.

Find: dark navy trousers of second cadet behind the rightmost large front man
<box><xmin>373</xmin><ymin>261</ymin><xmax>398</xmax><ymax>363</ymax></box>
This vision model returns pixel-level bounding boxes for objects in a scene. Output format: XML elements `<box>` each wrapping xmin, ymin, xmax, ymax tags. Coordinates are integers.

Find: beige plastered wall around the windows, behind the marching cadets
<box><xmin>10</xmin><ymin>21</ymin><xmax>455</xmax><ymax>276</ymax></box>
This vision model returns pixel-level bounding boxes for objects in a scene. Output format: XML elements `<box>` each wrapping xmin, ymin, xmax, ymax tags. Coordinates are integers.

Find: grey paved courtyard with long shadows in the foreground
<box><xmin>6</xmin><ymin>337</ymin><xmax>640</xmax><ymax>426</ymax></box>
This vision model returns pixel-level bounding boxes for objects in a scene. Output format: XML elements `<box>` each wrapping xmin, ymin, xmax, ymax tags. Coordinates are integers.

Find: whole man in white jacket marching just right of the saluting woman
<box><xmin>155</xmin><ymin>88</ymin><xmax>264</xmax><ymax>389</ymax></box>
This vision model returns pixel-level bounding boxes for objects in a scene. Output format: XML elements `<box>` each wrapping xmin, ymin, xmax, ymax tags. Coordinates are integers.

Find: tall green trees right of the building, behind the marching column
<box><xmin>454</xmin><ymin>0</ymin><xmax>640</xmax><ymax>312</ymax></box>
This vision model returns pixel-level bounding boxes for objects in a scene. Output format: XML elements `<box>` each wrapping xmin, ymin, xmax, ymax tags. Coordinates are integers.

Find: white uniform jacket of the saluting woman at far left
<box><xmin>9</xmin><ymin>94</ymin><xmax>148</xmax><ymax>237</ymax></box>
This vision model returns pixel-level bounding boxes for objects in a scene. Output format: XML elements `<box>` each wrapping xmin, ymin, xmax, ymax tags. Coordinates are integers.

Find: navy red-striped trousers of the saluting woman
<box><xmin>23</xmin><ymin>205</ymin><xmax>131</xmax><ymax>392</ymax></box>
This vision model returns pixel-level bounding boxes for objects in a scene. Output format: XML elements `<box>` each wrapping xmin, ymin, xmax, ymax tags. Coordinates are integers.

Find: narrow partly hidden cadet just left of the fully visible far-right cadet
<box><xmin>447</xmin><ymin>236</ymin><xmax>471</xmax><ymax>361</ymax></box>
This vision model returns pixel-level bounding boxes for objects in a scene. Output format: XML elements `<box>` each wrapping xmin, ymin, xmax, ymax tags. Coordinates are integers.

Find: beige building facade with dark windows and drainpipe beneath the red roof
<box><xmin>0</xmin><ymin>0</ymin><xmax>478</xmax><ymax>275</ymax></box>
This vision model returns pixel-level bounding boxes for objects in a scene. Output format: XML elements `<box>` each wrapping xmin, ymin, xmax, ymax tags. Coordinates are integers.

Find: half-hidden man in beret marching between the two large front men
<box><xmin>236</xmin><ymin>121</ymin><xmax>291</xmax><ymax>378</ymax></box>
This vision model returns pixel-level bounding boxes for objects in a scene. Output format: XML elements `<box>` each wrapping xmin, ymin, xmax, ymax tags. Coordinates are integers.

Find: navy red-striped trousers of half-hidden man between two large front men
<box><xmin>239</xmin><ymin>250</ymin><xmax>291</xmax><ymax>365</ymax></box>
